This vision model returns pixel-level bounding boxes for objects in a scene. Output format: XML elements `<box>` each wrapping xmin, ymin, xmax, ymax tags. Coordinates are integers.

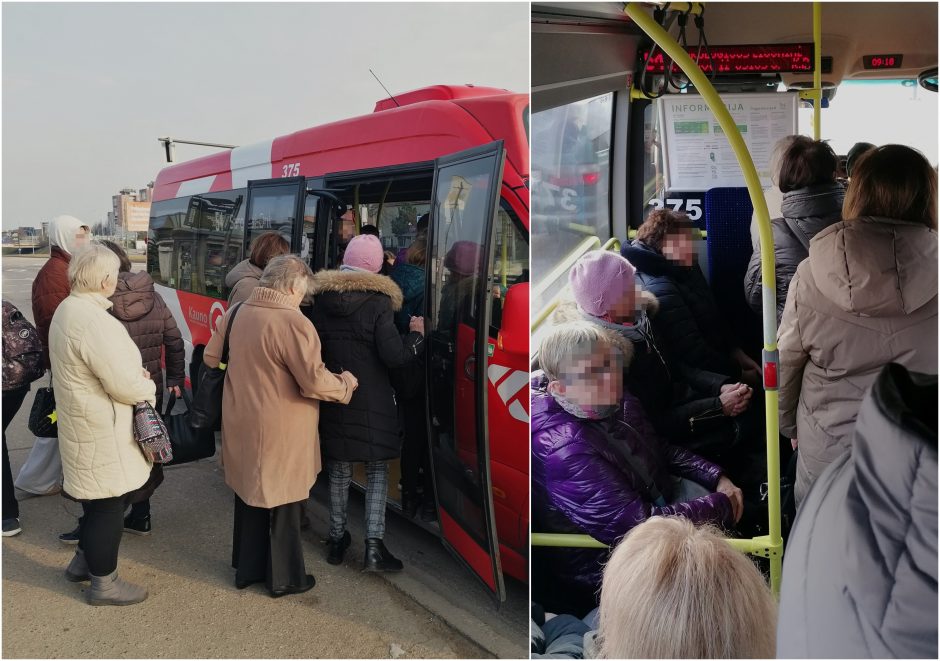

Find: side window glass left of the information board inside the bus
<box><xmin>531</xmin><ymin>93</ymin><xmax>614</xmax><ymax>310</ymax></box>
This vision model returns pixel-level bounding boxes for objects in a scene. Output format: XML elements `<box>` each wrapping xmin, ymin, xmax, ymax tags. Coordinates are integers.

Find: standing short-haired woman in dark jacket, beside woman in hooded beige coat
<box><xmin>744</xmin><ymin>135</ymin><xmax>845</xmax><ymax>324</ymax></box>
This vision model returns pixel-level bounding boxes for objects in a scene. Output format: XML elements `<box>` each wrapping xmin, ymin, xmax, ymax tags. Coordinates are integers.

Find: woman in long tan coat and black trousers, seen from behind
<box><xmin>205</xmin><ymin>255</ymin><xmax>358</xmax><ymax>597</ymax></box>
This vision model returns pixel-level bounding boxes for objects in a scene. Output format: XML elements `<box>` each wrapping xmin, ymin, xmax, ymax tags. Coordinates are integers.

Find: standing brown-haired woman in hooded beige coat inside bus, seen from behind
<box><xmin>778</xmin><ymin>145</ymin><xmax>937</xmax><ymax>504</ymax></box>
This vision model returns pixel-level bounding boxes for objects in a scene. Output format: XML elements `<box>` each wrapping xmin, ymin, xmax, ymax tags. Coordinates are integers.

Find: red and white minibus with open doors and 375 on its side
<box><xmin>147</xmin><ymin>85</ymin><xmax>529</xmax><ymax>600</ymax></box>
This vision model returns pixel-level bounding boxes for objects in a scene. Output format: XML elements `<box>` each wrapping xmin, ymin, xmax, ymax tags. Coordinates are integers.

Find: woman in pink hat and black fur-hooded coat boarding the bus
<box><xmin>309</xmin><ymin>235</ymin><xmax>424</xmax><ymax>571</ymax></box>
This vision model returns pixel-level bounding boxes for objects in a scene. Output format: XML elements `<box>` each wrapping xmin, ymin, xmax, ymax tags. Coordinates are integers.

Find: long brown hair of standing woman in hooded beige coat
<box><xmin>842</xmin><ymin>145</ymin><xmax>937</xmax><ymax>229</ymax></box>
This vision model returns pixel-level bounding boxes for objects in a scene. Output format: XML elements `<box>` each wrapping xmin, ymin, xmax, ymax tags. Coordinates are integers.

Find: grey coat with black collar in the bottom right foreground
<box><xmin>777</xmin><ymin>363</ymin><xmax>937</xmax><ymax>659</ymax></box>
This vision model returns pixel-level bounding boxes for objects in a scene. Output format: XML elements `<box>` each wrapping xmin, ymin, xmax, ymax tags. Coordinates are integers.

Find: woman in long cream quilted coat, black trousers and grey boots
<box><xmin>49</xmin><ymin>245</ymin><xmax>156</xmax><ymax>605</ymax></box>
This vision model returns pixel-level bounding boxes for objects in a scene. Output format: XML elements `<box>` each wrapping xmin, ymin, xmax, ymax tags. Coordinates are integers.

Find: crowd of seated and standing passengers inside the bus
<box><xmin>531</xmin><ymin>142</ymin><xmax>938</xmax><ymax>658</ymax></box>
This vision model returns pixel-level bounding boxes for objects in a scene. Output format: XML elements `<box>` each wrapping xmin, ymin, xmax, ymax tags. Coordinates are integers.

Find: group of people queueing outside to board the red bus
<box><xmin>3</xmin><ymin>216</ymin><xmax>436</xmax><ymax>605</ymax></box>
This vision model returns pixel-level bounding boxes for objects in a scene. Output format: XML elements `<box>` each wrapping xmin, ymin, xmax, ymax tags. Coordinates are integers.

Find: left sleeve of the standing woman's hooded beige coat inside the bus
<box><xmin>777</xmin><ymin>269</ymin><xmax>809</xmax><ymax>438</ymax></box>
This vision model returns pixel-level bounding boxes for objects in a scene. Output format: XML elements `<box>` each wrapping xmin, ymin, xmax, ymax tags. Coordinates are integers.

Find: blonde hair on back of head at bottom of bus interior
<box><xmin>598</xmin><ymin>516</ymin><xmax>777</xmax><ymax>659</ymax></box>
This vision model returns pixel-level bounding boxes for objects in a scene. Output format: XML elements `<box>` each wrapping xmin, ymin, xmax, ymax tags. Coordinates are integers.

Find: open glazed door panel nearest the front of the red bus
<box><xmin>425</xmin><ymin>141</ymin><xmax>506</xmax><ymax>601</ymax></box>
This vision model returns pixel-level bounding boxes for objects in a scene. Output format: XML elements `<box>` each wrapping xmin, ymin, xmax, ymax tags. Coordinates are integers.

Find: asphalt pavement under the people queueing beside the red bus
<box><xmin>2</xmin><ymin>257</ymin><xmax>528</xmax><ymax>658</ymax></box>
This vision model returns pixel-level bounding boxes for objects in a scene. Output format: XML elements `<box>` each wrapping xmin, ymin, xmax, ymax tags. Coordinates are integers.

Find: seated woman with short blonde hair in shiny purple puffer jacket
<box><xmin>531</xmin><ymin>321</ymin><xmax>743</xmax><ymax>614</ymax></box>
